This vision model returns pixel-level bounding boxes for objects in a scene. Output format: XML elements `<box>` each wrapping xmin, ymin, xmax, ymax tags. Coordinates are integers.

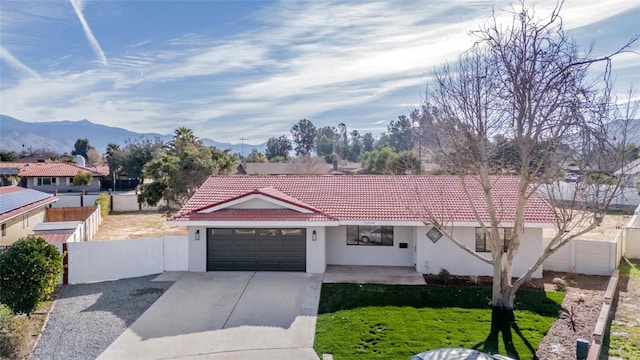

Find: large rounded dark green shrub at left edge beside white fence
<box><xmin>0</xmin><ymin>236</ymin><xmax>63</xmax><ymax>314</ymax></box>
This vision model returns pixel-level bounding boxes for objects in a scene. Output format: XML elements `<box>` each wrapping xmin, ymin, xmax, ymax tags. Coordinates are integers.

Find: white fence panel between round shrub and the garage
<box><xmin>67</xmin><ymin>236</ymin><xmax>188</xmax><ymax>284</ymax></box>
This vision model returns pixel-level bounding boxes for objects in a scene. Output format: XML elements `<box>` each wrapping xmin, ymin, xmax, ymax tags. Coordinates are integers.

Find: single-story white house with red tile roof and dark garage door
<box><xmin>169</xmin><ymin>175</ymin><xmax>556</xmax><ymax>277</ymax></box>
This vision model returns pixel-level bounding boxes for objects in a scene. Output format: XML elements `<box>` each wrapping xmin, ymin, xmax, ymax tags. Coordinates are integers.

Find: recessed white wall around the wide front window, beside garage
<box><xmin>326</xmin><ymin>226</ymin><xmax>415</xmax><ymax>266</ymax></box>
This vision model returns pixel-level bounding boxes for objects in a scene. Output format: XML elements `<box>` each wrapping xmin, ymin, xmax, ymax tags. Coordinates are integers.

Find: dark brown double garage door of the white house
<box><xmin>207</xmin><ymin>228</ymin><xmax>306</xmax><ymax>271</ymax></box>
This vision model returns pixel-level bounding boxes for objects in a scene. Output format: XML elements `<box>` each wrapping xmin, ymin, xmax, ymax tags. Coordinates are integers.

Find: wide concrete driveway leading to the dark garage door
<box><xmin>99</xmin><ymin>272</ymin><xmax>322</xmax><ymax>360</ymax></box>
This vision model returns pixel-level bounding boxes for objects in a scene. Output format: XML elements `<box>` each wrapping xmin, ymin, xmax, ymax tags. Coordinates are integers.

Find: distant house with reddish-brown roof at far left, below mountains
<box><xmin>0</xmin><ymin>162</ymin><xmax>105</xmax><ymax>193</ymax></box>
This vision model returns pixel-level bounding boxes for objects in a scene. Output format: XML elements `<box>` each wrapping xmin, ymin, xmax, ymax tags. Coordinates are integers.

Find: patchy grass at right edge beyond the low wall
<box><xmin>605</xmin><ymin>258</ymin><xmax>640</xmax><ymax>359</ymax></box>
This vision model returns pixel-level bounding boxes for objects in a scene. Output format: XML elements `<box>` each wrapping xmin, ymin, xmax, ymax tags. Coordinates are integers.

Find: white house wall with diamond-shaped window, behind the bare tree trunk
<box><xmin>416</xmin><ymin>226</ymin><xmax>543</xmax><ymax>278</ymax></box>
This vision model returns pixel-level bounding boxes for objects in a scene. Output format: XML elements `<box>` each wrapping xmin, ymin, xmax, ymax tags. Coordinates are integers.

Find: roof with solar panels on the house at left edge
<box><xmin>0</xmin><ymin>186</ymin><xmax>58</xmax><ymax>222</ymax></box>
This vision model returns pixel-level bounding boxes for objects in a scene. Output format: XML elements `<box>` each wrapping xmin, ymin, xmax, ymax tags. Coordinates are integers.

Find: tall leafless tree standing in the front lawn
<box><xmin>424</xmin><ymin>1</ymin><xmax>638</xmax><ymax>351</ymax></box>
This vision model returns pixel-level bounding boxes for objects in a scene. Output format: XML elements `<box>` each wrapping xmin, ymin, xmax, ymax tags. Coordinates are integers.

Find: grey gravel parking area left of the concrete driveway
<box><xmin>33</xmin><ymin>275</ymin><xmax>174</xmax><ymax>360</ymax></box>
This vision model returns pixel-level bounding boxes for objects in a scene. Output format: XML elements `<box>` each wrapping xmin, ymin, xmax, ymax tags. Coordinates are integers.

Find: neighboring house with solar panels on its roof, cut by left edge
<box><xmin>0</xmin><ymin>186</ymin><xmax>58</xmax><ymax>245</ymax></box>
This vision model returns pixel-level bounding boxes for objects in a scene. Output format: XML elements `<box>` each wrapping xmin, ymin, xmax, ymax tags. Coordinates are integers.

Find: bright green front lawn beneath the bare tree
<box><xmin>315</xmin><ymin>284</ymin><xmax>564</xmax><ymax>360</ymax></box>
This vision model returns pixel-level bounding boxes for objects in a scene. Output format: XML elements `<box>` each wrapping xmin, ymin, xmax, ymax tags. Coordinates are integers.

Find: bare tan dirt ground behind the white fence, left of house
<box><xmin>94</xmin><ymin>211</ymin><xmax>187</xmax><ymax>240</ymax></box>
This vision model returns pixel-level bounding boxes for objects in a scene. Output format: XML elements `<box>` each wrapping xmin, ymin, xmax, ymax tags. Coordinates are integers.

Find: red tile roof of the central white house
<box><xmin>172</xmin><ymin>175</ymin><xmax>556</xmax><ymax>223</ymax></box>
